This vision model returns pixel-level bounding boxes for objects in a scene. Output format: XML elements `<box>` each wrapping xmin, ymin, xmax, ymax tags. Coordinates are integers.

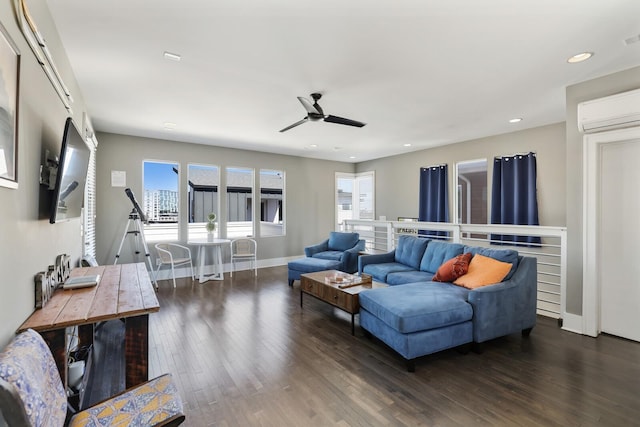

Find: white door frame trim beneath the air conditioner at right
<box><xmin>582</xmin><ymin>127</ymin><xmax>640</xmax><ymax>337</ymax></box>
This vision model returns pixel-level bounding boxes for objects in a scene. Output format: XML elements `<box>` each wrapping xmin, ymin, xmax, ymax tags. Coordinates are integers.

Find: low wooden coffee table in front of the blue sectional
<box><xmin>300</xmin><ymin>270</ymin><xmax>388</xmax><ymax>335</ymax></box>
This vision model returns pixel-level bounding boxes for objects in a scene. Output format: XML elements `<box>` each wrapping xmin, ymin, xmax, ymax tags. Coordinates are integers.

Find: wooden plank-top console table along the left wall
<box><xmin>18</xmin><ymin>263</ymin><xmax>160</xmax><ymax>388</ymax></box>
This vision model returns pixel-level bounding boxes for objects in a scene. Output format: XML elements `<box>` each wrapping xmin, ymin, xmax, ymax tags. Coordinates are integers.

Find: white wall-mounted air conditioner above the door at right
<box><xmin>578</xmin><ymin>89</ymin><xmax>640</xmax><ymax>133</ymax></box>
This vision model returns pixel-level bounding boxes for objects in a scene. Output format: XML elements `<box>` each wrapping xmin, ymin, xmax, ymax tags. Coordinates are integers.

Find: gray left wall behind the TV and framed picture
<box><xmin>0</xmin><ymin>1</ymin><xmax>89</xmax><ymax>347</ymax></box>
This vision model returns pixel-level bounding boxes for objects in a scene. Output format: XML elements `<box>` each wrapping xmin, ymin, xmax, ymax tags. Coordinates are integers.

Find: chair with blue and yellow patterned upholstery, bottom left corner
<box><xmin>0</xmin><ymin>329</ymin><xmax>185</xmax><ymax>427</ymax></box>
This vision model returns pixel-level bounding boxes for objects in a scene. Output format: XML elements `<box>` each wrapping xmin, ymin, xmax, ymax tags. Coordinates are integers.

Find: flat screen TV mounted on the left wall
<box><xmin>49</xmin><ymin>117</ymin><xmax>91</xmax><ymax>224</ymax></box>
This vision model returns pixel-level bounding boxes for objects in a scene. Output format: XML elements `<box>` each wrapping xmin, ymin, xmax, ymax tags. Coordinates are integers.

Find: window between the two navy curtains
<box><xmin>455</xmin><ymin>159</ymin><xmax>488</xmax><ymax>229</ymax></box>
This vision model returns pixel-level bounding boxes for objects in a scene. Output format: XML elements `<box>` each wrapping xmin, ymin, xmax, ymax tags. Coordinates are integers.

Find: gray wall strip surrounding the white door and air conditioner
<box><xmin>566</xmin><ymin>67</ymin><xmax>640</xmax><ymax>314</ymax></box>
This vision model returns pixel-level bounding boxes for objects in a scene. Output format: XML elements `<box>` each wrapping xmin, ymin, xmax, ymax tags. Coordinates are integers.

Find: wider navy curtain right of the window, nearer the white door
<box><xmin>491</xmin><ymin>153</ymin><xmax>540</xmax><ymax>246</ymax></box>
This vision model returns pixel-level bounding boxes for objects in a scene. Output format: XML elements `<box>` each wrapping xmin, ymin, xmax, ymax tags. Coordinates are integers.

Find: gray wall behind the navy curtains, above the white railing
<box><xmin>357</xmin><ymin>123</ymin><xmax>566</xmax><ymax>226</ymax></box>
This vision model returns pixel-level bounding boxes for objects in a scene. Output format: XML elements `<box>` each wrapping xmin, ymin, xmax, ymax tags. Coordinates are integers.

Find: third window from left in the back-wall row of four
<box><xmin>226</xmin><ymin>167</ymin><xmax>253</xmax><ymax>238</ymax></box>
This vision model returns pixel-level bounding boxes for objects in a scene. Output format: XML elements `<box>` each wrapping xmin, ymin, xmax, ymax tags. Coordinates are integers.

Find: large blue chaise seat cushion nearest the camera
<box><xmin>359</xmin><ymin>282</ymin><xmax>473</xmax><ymax>334</ymax></box>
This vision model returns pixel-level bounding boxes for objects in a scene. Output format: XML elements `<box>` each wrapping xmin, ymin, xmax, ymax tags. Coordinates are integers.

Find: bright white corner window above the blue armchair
<box><xmin>336</xmin><ymin>171</ymin><xmax>375</xmax><ymax>227</ymax></box>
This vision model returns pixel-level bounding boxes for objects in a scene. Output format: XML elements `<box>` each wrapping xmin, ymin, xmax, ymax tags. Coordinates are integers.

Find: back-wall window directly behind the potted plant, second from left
<box><xmin>187</xmin><ymin>164</ymin><xmax>221</xmax><ymax>240</ymax></box>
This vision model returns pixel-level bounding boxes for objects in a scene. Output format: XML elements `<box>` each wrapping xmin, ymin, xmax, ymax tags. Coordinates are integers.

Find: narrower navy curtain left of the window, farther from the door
<box><xmin>418</xmin><ymin>165</ymin><xmax>449</xmax><ymax>236</ymax></box>
